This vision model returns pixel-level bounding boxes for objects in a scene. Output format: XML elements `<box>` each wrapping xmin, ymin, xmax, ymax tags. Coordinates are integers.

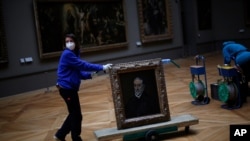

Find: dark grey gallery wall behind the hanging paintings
<box><xmin>0</xmin><ymin>0</ymin><xmax>250</xmax><ymax>97</ymax></box>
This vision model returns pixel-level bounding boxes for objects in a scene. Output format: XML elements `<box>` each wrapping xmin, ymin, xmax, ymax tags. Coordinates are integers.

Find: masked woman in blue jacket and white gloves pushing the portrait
<box><xmin>54</xmin><ymin>34</ymin><xmax>112</xmax><ymax>141</ymax></box>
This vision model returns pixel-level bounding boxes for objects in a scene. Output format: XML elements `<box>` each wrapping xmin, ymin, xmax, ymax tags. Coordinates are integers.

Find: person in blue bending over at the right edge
<box><xmin>222</xmin><ymin>41</ymin><xmax>250</xmax><ymax>102</ymax></box>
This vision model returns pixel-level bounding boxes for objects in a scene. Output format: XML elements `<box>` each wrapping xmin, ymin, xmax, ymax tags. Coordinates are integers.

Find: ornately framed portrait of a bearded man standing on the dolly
<box><xmin>109</xmin><ymin>58</ymin><xmax>170</xmax><ymax>129</ymax></box>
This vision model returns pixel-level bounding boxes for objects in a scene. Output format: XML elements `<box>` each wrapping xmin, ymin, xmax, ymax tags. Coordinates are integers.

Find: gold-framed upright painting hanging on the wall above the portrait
<box><xmin>137</xmin><ymin>0</ymin><xmax>173</xmax><ymax>43</ymax></box>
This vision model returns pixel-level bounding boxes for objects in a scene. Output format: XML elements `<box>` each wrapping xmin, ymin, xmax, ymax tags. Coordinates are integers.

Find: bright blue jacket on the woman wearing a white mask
<box><xmin>57</xmin><ymin>48</ymin><xmax>103</xmax><ymax>91</ymax></box>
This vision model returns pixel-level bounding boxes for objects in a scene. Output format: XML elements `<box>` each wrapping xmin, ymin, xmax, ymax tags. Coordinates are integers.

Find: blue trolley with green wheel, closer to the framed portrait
<box><xmin>189</xmin><ymin>55</ymin><xmax>210</xmax><ymax>105</ymax></box>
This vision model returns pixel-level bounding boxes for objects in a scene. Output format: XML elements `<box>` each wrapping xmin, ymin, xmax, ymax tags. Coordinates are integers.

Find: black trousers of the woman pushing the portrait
<box><xmin>56</xmin><ymin>88</ymin><xmax>82</xmax><ymax>141</ymax></box>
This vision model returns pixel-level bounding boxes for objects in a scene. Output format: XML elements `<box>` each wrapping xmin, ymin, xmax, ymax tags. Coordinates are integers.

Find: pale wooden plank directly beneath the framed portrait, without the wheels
<box><xmin>94</xmin><ymin>114</ymin><xmax>199</xmax><ymax>140</ymax></box>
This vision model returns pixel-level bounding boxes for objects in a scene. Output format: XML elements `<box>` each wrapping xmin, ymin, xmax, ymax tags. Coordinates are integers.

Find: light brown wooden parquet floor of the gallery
<box><xmin>0</xmin><ymin>52</ymin><xmax>250</xmax><ymax>141</ymax></box>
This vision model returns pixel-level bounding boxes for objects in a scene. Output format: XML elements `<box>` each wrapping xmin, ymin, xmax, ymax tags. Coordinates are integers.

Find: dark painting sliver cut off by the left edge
<box><xmin>0</xmin><ymin>1</ymin><xmax>8</xmax><ymax>67</ymax></box>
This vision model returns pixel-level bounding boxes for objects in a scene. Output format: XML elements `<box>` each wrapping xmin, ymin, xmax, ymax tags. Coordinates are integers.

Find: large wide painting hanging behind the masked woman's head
<box><xmin>33</xmin><ymin>0</ymin><xmax>128</xmax><ymax>58</ymax></box>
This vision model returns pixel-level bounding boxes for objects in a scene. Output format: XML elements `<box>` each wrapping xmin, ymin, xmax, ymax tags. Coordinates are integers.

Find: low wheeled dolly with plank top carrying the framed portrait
<box><xmin>94</xmin><ymin>114</ymin><xmax>199</xmax><ymax>141</ymax></box>
